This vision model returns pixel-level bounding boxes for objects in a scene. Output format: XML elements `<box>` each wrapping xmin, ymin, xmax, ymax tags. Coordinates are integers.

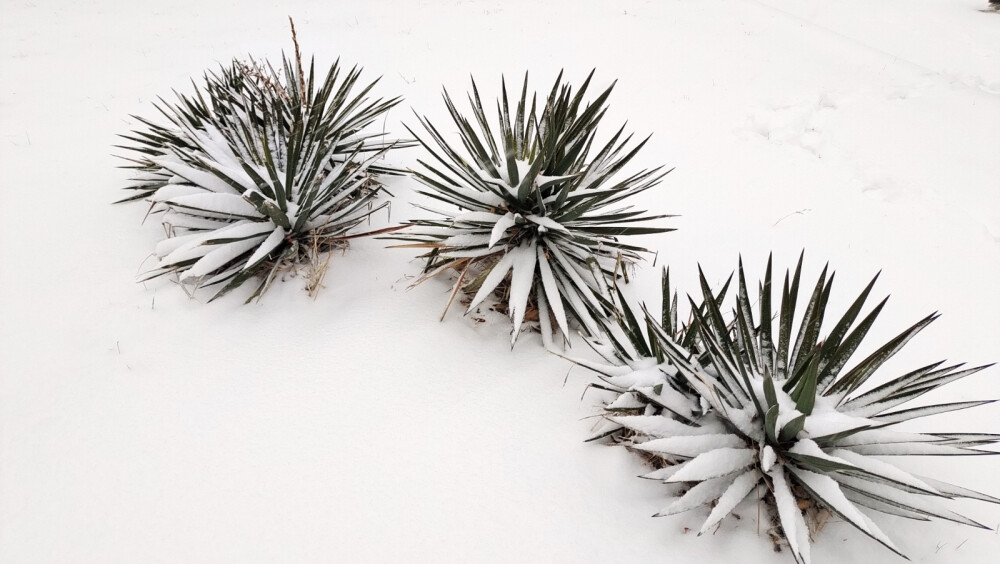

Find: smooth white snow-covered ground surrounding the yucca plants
<box><xmin>0</xmin><ymin>0</ymin><xmax>1000</xmax><ymax>563</ymax></box>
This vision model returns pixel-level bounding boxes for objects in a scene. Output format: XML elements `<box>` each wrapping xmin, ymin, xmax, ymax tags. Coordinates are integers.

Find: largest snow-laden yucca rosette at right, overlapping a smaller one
<box><xmin>612</xmin><ymin>253</ymin><xmax>1000</xmax><ymax>562</ymax></box>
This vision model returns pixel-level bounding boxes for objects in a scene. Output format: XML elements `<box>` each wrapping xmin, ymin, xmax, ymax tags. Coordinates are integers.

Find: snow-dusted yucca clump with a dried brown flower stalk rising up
<box><xmin>124</xmin><ymin>23</ymin><xmax>401</xmax><ymax>301</ymax></box>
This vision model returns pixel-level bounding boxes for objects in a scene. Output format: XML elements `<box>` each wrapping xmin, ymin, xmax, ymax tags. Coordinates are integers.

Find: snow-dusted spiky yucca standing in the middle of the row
<box><xmin>390</xmin><ymin>72</ymin><xmax>671</xmax><ymax>345</ymax></box>
